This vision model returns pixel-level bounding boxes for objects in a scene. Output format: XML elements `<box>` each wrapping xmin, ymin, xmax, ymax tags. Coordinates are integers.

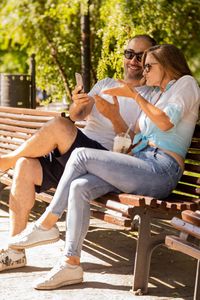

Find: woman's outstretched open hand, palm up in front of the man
<box><xmin>103</xmin><ymin>80</ymin><xmax>137</xmax><ymax>99</ymax></box>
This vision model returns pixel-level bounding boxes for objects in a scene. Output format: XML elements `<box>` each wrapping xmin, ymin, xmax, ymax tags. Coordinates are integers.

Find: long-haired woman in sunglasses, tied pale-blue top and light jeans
<box><xmin>11</xmin><ymin>45</ymin><xmax>200</xmax><ymax>289</ymax></box>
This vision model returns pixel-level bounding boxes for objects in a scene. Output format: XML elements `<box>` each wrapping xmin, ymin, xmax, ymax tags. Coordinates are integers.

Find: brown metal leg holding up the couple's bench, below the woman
<box><xmin>132</xmin><ymin>209</ymin><xmax>166</xmax><ymax>295</ymax></box>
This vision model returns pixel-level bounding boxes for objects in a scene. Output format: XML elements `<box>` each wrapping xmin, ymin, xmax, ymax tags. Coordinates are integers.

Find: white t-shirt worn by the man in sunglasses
<box><xmin>81</xmin><ymin>78</ymin><xmax>152</xmax><ymax>150</ymax></box>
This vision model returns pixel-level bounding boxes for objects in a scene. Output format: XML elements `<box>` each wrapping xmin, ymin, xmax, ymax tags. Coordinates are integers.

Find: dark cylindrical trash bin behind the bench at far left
<box><xmin>0</xmin><ymin>74</ymin><xmax>31</xmax><ymax>108</ymax></box>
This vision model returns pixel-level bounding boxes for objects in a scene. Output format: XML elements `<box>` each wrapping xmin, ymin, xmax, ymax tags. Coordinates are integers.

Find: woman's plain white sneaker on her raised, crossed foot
<box><xmin>8</xmin><ymin>223</ymin><xmax>60</xmax><ymax>249</ymax></box>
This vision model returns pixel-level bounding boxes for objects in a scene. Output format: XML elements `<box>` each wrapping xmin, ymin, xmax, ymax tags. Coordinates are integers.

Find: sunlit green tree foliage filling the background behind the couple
<box><xmin>0</xmin><ymin>0</ymin><xmax>200</xmax><ymax>104</ymax></box>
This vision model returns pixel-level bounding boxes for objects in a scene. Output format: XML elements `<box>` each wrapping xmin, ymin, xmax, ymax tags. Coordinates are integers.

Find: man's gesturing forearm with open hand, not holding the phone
<box><xmin>94</xmin><ymin>95</ymin><xmax>134</xmax><ymax>138</ymax></box>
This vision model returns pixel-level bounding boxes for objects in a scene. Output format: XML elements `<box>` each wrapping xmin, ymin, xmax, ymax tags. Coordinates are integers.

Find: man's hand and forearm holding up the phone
<box><xmin>69</xmin><ymin>87</ymin><xmax>94</xmax><ymax>121</ymax></box>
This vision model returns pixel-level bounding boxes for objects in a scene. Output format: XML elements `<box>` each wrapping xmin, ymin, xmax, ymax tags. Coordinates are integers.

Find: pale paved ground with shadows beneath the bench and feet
<box><xmin>0</xmin><ymin>191</ymin><xmax>196</xmax><ymax>300</ymax></box>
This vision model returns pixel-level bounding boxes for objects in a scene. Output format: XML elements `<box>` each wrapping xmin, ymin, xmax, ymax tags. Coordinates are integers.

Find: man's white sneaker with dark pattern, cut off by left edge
<box><xmin>0</xmin><ymin>248</ymin><xmax>26</xmax><ymax>272</ymax></box>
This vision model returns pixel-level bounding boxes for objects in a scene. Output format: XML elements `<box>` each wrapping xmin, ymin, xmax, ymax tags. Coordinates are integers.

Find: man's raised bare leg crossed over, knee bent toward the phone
<box><xmin>0</xmin><ymin>117</ymin><xmax>77</xmax><ymax>171</ymax></box>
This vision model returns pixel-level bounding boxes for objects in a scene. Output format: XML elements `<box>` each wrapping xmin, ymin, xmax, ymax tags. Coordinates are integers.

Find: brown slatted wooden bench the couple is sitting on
<box><xmin>0</xmin><ymin>107</ymin><xmax>200</xmax><ymax>294</ymax></box>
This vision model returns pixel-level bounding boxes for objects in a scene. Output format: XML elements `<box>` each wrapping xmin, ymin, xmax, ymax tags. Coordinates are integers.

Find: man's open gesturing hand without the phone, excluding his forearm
<box><xmin>94</xmin><ymin>95</ymin><xmax>120</xmax><ymax>122</ymax></box>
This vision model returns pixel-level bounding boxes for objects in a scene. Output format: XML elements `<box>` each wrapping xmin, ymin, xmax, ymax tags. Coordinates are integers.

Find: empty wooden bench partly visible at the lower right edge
<box><xmin>165</xmin><ymin>210</ymin><xmax>200</xmax><ymax>300</ymax></box>
